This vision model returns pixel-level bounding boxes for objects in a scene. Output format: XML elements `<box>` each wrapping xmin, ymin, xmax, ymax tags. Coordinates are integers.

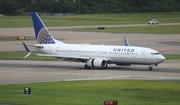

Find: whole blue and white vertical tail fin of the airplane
<box><xmin>31</xmin><ymin>12</ymin><xmax>62</xmax><ymax>44</ymax></box>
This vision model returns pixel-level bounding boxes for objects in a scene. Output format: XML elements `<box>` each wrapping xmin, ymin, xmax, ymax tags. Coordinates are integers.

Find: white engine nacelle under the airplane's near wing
<box><xmin>86</xmin><ymin>58</ymin><xmax>107</xmax><ymax>68</ymax></box>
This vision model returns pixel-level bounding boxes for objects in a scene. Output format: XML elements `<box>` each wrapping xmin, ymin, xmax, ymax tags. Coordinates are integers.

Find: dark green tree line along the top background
<box><xmin>0</xmin><ymin>0</ymin><xmax>180</xmax><ymax>15</ymax></box>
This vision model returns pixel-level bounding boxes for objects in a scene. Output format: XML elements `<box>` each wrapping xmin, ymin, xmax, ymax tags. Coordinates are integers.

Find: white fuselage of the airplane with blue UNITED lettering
<box><xmin>36</xmin><ymin>44</ymin><xmax>165</xmax><ymax>65</ymax></box>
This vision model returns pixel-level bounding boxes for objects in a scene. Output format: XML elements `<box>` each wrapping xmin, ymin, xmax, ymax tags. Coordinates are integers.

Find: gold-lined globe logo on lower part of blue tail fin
<box><xmin>37</xmin><ymin>27</ymin><xmax>55</xmax><ymax>44</ymax></box>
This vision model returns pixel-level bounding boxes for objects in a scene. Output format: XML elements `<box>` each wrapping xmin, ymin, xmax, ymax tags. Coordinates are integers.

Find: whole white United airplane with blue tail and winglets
<box><xmin>23</xmin><ymin>12</ymin><xmax>165</xmax><ymax>70</ymax></box>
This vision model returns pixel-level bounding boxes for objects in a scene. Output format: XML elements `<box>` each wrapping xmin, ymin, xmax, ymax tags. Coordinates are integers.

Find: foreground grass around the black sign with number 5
<box><xmin>0</xmin><ymin>80</ymin><xmax>180</xmax><ymax>105</ymax></box>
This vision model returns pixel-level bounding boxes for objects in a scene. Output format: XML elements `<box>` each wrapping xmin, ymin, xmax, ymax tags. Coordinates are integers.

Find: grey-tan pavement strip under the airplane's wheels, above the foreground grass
<box><xmin>0</xmin><ymin>60</ymin><xmax>180</xmax><ymax>84</ymax></box>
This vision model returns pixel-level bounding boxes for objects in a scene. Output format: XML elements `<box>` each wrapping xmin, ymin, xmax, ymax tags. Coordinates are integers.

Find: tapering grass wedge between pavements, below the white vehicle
<box><xmin>77</xmin><ymin>25</ymin><xmax>180</xmax><ymax>34</ymax></box>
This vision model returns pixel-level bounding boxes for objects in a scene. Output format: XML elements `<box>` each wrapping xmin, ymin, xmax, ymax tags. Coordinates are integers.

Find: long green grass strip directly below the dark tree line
<box><xmin>0</xmin><ymin>12</ymin><xmax>180</xmax><ymax>28</ymax></box>
